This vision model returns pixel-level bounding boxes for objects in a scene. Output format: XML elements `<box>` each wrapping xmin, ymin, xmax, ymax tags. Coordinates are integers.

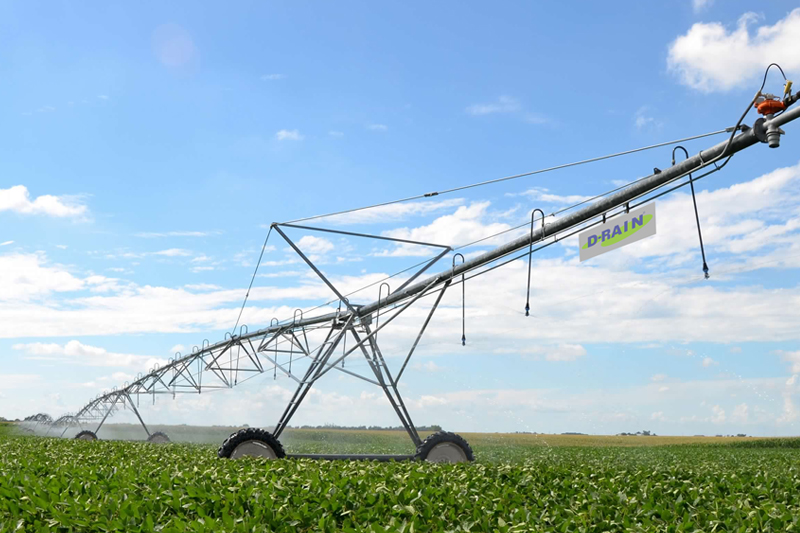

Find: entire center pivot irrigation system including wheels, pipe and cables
<box><xmin>40</xmin><ymin>65</ymin><xmax>800</xmax><ymax>462</ymax></box>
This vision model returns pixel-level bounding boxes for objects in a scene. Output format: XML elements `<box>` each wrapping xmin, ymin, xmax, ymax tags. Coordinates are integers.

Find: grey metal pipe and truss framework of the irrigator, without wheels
<box><xmin>43</xmin><ymin>106</ymin><xmax>800</xmax><ymax>448</ymax></box>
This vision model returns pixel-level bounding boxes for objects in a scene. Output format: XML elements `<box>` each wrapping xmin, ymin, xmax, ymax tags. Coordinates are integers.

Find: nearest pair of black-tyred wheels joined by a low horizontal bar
<box><xmin>217</xmin><ymin>428</ymin><xmax>475</xmax><ymax>463</ymax></box>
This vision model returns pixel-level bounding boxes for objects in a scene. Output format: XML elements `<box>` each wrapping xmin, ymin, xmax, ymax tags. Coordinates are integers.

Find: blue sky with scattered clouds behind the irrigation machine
<box><xmin>0</xmin><ymin>0</ymin><xmax>800</xmax><ymax>435</ymax></box>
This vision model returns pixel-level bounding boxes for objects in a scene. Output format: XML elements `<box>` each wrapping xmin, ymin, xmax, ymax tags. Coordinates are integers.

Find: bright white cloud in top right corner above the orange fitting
<box><xmin>667</xmin><ymin>8</ymin><xmax>800</xmax><ymax>92</ymax></box>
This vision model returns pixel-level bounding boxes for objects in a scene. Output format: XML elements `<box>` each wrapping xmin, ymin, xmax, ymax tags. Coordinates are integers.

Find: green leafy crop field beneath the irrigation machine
<box><xmin>0</xmin><ymin>431</ymin><xmax>800</xmax><ymax>532</ymax></box>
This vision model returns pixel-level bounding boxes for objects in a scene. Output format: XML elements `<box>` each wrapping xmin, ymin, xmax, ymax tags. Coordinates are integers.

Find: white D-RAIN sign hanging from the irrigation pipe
<box><xmin>578</xmin><ymin>203</ymin><xmax>656</xmax><ymax>261</ymax></box>
